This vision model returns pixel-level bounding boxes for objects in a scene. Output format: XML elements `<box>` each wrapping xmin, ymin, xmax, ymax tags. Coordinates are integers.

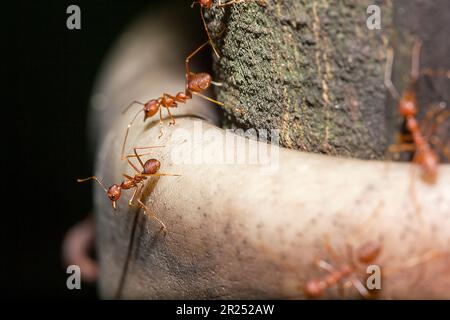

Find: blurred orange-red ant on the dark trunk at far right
<box><xmin>384</xmin><ymin>40</ymin><xmax>450</xmax><ymax>183</ymax></box>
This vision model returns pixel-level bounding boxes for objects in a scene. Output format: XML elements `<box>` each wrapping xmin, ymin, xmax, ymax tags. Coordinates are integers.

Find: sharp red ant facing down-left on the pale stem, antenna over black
<box><xmin>77</xmin><ymin>146</ymin><xmax>180</xmax><ymax>232</ymax></box>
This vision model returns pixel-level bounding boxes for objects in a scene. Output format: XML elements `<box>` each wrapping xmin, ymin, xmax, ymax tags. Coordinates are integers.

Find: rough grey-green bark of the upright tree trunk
<box><xmin>208</xmin><ymin>0</ymin><xmax>450</xmax><ymax>159</ymax></box>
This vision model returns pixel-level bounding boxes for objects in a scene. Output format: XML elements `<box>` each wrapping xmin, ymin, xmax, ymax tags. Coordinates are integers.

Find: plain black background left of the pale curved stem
<box><xmin>7</xmin><ymin>0</ymin><xmax>198</xmax><ymax>298</ymax></box>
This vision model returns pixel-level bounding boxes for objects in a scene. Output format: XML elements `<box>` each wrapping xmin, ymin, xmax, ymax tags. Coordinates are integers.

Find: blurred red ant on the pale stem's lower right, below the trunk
<box><xmin>304</xmin><ymin>242</ymin><xmax>381</xmax><ymax>298</ymax></box>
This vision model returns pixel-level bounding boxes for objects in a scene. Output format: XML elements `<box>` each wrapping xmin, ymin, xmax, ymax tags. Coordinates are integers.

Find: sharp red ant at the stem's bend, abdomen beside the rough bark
<box><xmin>121</xmin><ymin>40</ymin><xmax>223</xmax><ymax>160</ymax></box>
